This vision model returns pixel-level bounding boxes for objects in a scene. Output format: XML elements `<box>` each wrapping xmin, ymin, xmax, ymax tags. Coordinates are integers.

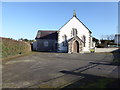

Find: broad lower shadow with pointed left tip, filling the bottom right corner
<box><xmin>60</xmin><ymin>71</ymin><xmax>120</xmax><ymax>89</ymax></box>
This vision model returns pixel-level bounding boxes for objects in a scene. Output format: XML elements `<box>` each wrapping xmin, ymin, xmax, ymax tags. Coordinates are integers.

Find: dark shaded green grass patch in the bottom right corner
<box><xmin>62</xmin><ymin>77</ymin><xmax>119</xmax><ymax>89</ymax></box>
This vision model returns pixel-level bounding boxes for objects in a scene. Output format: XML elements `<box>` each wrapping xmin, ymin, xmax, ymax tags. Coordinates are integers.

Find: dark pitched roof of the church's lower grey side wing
<box><xmin>35</xmin><ymin>30</ymin><xmax>58</xmax><ymax>40</ymax></box>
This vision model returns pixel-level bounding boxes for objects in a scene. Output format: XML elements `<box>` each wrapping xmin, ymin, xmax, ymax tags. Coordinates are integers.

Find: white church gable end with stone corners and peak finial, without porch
<box><xmin>58</xmin><ymin>11</ymin><xmax>92</xmax><ymax>52</ymax></box>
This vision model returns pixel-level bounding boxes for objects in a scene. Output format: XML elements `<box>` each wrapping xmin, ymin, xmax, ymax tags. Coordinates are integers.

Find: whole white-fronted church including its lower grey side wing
<box><xmin>35</xmin><ymin>11</ymin><xmax>95</xmax><ymax>53</ymax></box>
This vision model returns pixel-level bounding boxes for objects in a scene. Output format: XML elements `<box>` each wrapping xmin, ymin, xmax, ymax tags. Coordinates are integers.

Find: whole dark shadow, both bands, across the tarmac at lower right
<box><xmin>60</xmin><ymin>49</ymin><xmax>120</xmax><ymax>89</ymax></box>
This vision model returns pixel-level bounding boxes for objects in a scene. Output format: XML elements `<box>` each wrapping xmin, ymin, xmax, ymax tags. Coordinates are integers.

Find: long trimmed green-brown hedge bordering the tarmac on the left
<box><xmin>0</xmin><ymin>37</ymin><xmax>31</xmax><ymax>58</ymax></box>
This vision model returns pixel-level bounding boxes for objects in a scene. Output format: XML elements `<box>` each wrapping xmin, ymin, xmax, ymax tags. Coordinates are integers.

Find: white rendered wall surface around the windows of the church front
<box><xmin>58</xmin><ymin>17</ymin><xmax>90</xmax><ymax>52</ymax></box>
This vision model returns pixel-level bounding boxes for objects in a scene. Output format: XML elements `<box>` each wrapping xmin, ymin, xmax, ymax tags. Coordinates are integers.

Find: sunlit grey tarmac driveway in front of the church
<box><xmin>2</xmin><ymin>52</ymin><xmax>117</xmax><ymax>88</ymax></box>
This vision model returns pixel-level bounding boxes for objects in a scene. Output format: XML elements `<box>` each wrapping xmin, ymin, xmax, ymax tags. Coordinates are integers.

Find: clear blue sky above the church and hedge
<box><xmin>1</xmin><ymin>2</ymin><xmax>118</xmax><ymax>40</ymax></box>
